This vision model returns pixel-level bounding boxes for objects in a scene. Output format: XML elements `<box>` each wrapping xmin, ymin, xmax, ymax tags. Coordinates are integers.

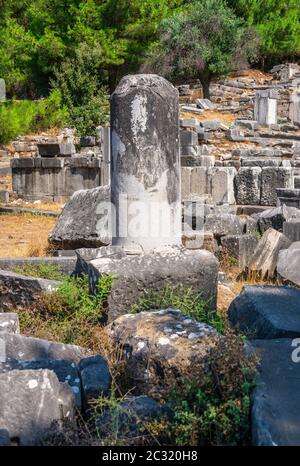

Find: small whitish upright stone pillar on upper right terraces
<box><xmin>254</xmin><ymin>89</ymin><xmax>278</xmax><ymax>125</ymax></box>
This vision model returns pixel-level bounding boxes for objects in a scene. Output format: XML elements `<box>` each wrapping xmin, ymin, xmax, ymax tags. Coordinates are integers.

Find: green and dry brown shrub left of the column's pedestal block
<box><xmin>17</xmin><ymin>275</ymin><xmax>113</xmax><ymax>349</ymax></box>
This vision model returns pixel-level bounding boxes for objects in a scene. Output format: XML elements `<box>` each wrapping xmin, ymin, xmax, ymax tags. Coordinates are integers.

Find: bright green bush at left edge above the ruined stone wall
<box><xmin>0</xmin><ymin>90</ymin><xmax>68</xmax><ymax>144</ymax></box>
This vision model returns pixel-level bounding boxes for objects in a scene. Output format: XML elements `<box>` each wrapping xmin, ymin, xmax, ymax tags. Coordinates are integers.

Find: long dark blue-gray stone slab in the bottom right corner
<box><xmin>250</xmin><ymin>338</ymin><xmax>300</xmax><ymax>446</ymax></box>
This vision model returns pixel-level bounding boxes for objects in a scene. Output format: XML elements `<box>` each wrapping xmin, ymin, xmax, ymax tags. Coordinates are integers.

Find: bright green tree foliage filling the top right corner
<box><xmin>227</xmin><ymin>0</ymin><xmax>300</xmax><ymax>62</ymax></box>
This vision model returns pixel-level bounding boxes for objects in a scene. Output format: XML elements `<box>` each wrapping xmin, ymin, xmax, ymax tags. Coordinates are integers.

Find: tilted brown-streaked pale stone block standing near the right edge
<box><xmin>246</xmin><ymin>228</ymin><xmax>291</xmax><ymax>279</ymax></box>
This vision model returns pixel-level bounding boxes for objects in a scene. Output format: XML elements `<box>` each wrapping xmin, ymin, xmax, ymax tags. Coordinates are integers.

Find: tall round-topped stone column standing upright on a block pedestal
<box><xmin>111</xmin><ymin>74</ymin><xmax>181</xmax><ymax>251</ymax></box>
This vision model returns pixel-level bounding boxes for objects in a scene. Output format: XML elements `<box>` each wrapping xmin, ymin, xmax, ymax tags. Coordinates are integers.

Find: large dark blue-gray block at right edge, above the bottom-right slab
<box><xmin>228</xmin><ymin>286</ymin><xmax>300</xmax><ymax>339</ymax></box>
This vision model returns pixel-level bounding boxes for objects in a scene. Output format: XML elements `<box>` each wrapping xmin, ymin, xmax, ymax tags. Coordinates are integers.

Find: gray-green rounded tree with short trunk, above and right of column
<box><xmin>144</xmin><ymin>0</ymin><xmax>254</xmax><ymax>98</ymax></box>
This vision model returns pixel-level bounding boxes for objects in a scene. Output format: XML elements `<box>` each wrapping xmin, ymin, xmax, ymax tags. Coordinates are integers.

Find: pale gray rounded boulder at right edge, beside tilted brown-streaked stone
<box><xmin>277</xmin><ymin>241</ymin><xmax>300</xmax><ymax>286</ymax></box>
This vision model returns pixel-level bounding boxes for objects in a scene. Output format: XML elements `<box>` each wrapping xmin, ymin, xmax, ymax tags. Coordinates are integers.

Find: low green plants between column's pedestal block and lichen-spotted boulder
<box><xmin>129</xmin><ymin>285</ymin><xmax>226</xmax><ymax>333</ymax></box>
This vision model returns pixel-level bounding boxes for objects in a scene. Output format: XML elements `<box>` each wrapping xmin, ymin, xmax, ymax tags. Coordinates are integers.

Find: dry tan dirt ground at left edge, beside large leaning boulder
<box><xmin>0</xmin><ymin>214</ymin><xmax>57</xmax><ymax>257</ymax></box>
